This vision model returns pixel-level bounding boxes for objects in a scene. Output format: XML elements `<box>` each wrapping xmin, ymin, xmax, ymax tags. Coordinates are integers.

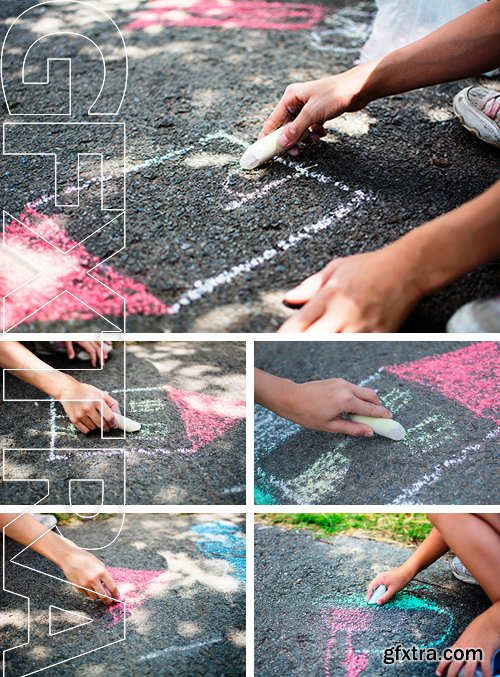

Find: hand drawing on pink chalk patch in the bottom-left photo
<box><xmin>60</xmin><ymin>541</ymin><xmax>120</xmax><ymax>604</ymax></box>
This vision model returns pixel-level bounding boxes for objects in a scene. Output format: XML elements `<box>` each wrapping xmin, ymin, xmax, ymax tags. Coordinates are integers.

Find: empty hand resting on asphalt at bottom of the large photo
<box><xmin>279</xmin><ymin>245</ymin><xmax>423</xmax><ymax>333</ymax></box>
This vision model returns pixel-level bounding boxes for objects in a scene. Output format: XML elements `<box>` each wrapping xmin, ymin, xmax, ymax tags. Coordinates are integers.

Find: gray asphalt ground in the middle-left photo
<box><xmin>0</xmin><ymin>341</ymin><xmax>245</xmax><ymax>505</ymax></box>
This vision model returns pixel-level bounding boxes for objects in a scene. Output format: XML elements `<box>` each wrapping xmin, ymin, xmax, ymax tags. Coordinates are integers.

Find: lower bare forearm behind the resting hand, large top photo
<box><xmin>389</xmin><ymin>181</ymin><xmax>500</xmax><ymax>295</ymax></box>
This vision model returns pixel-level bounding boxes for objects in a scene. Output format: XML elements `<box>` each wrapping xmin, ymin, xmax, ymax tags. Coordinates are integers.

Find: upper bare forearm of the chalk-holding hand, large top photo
<box><xmin>357</xmin><ymin>0</ymin><xmax>500</xmax><ymax>104</ymax></box>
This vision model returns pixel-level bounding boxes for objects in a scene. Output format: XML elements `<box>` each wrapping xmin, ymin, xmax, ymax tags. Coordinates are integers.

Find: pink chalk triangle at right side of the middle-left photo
<box><xmin>167</xmin><ymin>388</ymin><xmax>245</xmax><ymax>451</ymax></box>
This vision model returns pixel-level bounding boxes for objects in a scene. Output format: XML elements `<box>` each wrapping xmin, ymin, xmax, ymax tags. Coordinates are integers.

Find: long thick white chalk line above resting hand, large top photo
<box><xmin>168</xmin><ymin>190</ymin><xmax>369</xmax><ymax>315</ymax></box>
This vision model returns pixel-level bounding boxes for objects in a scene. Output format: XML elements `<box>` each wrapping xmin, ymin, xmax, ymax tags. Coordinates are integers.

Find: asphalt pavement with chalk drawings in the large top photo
<box><xmin>0</xmin><ymin>0</ymin><xmax>499</xmax><ymax>332</ymax></box>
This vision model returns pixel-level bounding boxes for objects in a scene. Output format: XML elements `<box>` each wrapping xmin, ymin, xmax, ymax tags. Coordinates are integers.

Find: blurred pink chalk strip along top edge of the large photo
<box><xmin>126</xmin><ymin>0</ymin><xmax>326</xmax><ymax>31</ymax></box>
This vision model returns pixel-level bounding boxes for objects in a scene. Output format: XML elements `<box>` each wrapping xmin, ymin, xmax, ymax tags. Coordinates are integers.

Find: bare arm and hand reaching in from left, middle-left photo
<box><xmin>0</xmin><ymin>341</ymin><xmax>119</xmax><ymax>433</ymax></box>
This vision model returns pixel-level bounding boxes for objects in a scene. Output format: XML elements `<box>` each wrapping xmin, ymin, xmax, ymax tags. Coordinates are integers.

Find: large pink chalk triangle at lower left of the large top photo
<box><xmin>0</xmin><ymin>207</ymin><xmax>168</xmax><ymax>328</ymax></box>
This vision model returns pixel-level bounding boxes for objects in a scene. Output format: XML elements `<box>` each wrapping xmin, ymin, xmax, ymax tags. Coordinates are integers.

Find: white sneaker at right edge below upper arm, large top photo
<box><xmin>453</xmin><ymin>87</ymin><xmax>500</xmax><ymax>148</ymax></box>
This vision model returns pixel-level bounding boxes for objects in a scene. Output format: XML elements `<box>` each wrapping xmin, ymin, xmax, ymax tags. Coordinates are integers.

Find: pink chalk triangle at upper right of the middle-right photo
<box><xmin>384</xmin><ymin>341</ymin><xmax>500</xmax><ymax>425</ymax></box>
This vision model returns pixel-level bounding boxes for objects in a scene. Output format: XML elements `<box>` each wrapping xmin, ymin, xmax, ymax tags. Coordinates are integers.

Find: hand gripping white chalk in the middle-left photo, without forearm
<box><xmin>55</xmin><ymin>379</ymin><xmax>120</xmax><ymax>433</ymax></box>
